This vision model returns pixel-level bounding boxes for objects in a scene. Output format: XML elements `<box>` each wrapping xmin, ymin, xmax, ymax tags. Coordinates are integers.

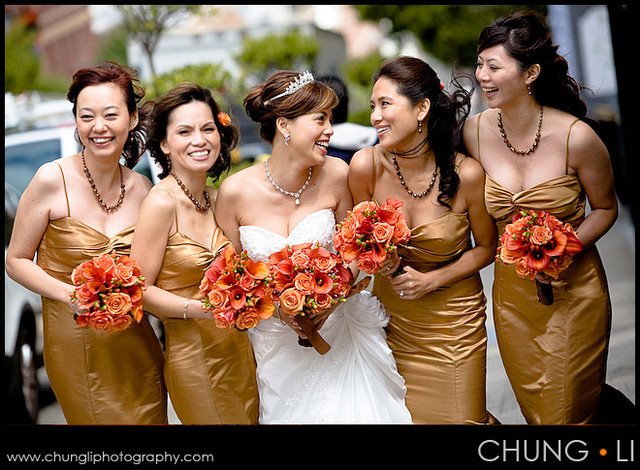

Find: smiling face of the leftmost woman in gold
<box><xmin>76</xmin><ymin>83</ymin><xmax>138</xmax><ymax>157</ymax></box>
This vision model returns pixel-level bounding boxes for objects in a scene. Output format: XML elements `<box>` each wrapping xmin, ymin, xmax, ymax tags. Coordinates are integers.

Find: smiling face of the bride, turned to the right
<box><xmin>286</xmin><ymin>109</ymin><xmax>333</xmax><ymax>164</ymax></box>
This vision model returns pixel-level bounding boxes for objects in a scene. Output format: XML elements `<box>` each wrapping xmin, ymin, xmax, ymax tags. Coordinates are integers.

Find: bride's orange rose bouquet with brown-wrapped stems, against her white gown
<box><xmin>268</xmin><ymin>243</ymin><xmax>353</xmax><ymax>354</ymax></box>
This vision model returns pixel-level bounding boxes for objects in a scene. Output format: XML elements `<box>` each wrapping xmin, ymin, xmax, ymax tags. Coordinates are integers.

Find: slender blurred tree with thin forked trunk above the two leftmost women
<box><xmin>116</xmin><ymin>5</ymin><xmax>202</xmax><ymax>77</ymax></box>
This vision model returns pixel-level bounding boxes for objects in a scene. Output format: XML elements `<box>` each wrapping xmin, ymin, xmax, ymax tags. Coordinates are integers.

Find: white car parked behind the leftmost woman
<box><xmin>4</xmin><ymin>126</ymin><xmax>161</xmax><ymax>423</ymax></box>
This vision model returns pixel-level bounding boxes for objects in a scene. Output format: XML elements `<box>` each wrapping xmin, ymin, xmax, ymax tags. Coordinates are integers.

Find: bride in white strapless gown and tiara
<box><xmin>216</xmin><ymin>71</ymin><xmax>411</xmax><ymax>424</ymax></box>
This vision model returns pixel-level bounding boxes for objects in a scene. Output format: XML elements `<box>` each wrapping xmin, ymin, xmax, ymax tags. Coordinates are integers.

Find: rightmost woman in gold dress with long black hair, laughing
<box><xmin>464</xmin><ymin>13</ymin><xmax>617</xmax><ymax>424</ymax></box>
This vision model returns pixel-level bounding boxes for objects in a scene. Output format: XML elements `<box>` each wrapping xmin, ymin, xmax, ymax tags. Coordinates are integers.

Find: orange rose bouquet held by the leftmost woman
<box><xmin>71</xmin><ymin>251</ymin><xmax>145</xmax><ymax>333</ymax></box>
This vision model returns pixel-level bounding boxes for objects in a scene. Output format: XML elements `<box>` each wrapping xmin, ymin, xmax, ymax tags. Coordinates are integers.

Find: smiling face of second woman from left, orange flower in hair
<box><xmin>160</xmin><ymin>101</ymin><xmax>220</xmax><ymax>172</ymax></box>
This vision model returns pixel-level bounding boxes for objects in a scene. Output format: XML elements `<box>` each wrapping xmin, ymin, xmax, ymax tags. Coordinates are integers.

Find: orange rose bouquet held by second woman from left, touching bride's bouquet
<box><xmin>200</xmin><ymin>245</ymin><xmax>274</xmax><ymax>330</ymax></box>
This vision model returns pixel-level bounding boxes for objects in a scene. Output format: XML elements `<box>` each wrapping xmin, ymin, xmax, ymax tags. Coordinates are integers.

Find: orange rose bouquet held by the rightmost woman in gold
<box><xmin>496</xmin><ymin>210</ymin><xmax>582</xmax><ymax>305</ymax></box>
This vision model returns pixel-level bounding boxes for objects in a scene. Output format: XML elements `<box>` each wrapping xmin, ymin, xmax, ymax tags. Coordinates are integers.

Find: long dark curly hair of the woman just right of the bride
<box><xmin>373</xmin><ymin>56</ymin><xmax>471</xmax><ymax>208</ymax></box>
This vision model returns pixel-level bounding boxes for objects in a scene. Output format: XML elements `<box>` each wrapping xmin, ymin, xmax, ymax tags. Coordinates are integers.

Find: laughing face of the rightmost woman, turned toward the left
<box><xmin>476</xmin><ymin>45</ymin><xmax>528</xmax><ymax>108</ymax></box>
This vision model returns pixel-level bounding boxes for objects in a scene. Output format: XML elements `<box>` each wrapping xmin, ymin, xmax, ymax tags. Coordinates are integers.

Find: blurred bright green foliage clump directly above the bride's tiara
<box><xmin>235</xmin><ymin>29</ymin><xmax>320</xmax><ymax>85</ymax></box>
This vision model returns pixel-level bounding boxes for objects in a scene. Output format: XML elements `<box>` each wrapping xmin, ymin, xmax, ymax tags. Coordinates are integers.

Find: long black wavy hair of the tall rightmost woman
<box><xmin>478</xmin><ymin>10</ymin><xmax>587</xmax><ymax>119</ymax></box>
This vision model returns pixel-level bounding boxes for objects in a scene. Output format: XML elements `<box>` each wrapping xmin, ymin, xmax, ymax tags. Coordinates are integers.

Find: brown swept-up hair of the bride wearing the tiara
<box><xmin>243</xmin><ymin>70</ymin><xmax>338</xmax><ymax>144</ymax></box>
